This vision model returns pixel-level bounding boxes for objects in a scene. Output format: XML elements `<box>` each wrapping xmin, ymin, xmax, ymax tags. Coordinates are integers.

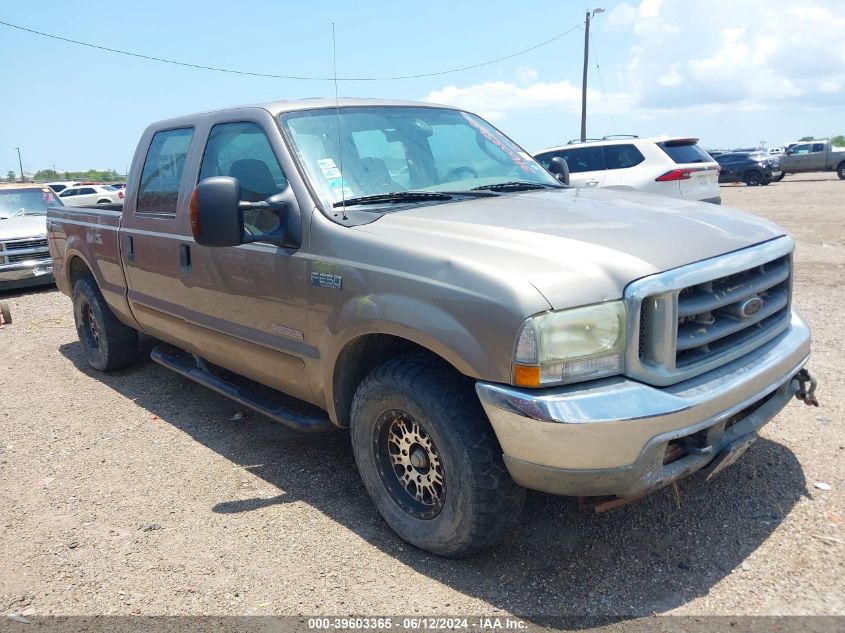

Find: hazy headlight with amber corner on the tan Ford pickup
<box><xmin>513</xmin><ymin>301</ymin><xmax>626</xmax><ymax>387</ymax></box>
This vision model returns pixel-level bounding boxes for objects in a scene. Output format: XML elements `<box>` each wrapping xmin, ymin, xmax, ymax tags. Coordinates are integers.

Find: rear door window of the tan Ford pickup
<box><xmin>136</xmin><ymin>128</ymin><xmax>194</xmax><ymax>215</ymax></box>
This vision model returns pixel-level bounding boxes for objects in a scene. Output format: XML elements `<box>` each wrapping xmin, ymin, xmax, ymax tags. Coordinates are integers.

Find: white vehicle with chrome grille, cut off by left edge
<box><xmin>0</xmin><ymin>185</ymin><xmax>62</xmax><ymax>291</ymax></box>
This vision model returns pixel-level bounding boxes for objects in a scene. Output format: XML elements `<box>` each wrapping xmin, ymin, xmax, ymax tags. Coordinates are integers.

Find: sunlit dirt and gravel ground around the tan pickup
<box><xmin>0</xmin><ymin>175</ymin><xmax>845</xmax><ymax>620</ymax></box>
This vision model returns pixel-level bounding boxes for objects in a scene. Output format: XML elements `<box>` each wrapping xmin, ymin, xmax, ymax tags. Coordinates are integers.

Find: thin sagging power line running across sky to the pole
<box><xmin>0</xmin><ymin>21</ymin><xmax>581</xmax><ymax>81</ymax></box>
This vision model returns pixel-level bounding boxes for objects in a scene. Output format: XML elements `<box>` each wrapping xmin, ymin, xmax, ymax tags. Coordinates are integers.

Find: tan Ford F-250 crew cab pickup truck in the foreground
<box><xmin>48</xmin><ymin>100</ymin><xmax>815</xmax><ymax>556</ymax></box>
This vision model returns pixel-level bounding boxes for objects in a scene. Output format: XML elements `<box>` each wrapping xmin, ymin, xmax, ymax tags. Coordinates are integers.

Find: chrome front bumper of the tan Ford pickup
<box><xmin>476</xmin><ymin>312</ymin><xmax>810</xmax><ymax>496</ymax></box>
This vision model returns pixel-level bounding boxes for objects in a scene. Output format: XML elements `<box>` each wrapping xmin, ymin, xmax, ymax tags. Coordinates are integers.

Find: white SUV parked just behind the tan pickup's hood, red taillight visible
<box><xmin>534</xmin><ymin>136</ymin><xmax>722</xmax><ymax>204</ymax></box>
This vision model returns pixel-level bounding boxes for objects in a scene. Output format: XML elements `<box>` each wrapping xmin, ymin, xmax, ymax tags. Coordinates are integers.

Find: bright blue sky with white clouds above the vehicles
<box><xmin>0</xmin><ymin>0</ymin><xmax>845</xmax><ymax>175</ymax></box>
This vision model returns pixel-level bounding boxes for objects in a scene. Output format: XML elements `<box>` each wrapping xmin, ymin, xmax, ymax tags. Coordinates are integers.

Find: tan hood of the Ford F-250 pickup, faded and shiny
<box><xmin>359</xmin><ymin>188</ymin><xmax>784</xmax><ymax>309</ymax></box>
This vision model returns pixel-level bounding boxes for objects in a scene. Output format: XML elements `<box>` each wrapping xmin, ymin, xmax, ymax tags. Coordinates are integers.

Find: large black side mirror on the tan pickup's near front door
<box><xmin>190</xmin><ymin>176</ymin><xmax>299</xmax><ymax>248</ymax></box>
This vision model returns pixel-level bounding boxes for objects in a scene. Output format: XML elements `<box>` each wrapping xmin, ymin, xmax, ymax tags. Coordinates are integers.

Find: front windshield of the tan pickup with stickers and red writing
<box><xmin>281</xmin><ymin>106</ymin><xmax>559</xmax><ymax>208</ymax></box>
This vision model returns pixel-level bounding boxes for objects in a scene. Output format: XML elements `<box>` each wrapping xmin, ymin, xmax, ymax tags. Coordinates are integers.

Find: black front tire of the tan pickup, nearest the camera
<box><xmin>350</xmin><ymin>353</ymin><xmax>525</xmax><ymax>558</ymax></box>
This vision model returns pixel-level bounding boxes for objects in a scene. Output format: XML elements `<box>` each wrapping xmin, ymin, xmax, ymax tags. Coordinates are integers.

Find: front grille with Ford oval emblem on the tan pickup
<box><xmin>626</xmin><ymin>237</ymin><xmax>793</xmax><ymax>386</ymax></box>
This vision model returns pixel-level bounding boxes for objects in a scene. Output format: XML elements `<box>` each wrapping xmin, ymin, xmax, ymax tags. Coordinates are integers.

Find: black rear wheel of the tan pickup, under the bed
<box><xmin>73</xmin><ymin>277</ymin><xmax>138</xmax><ymax>372</ymax></box>
